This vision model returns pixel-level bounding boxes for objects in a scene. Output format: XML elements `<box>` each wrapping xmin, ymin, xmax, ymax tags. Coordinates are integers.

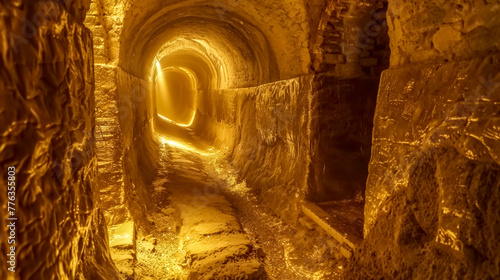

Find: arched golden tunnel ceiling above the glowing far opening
<box><xmin>119</xmin><ymin>0</ymin><xmax>310</xmax><ymax>87</ymax></box>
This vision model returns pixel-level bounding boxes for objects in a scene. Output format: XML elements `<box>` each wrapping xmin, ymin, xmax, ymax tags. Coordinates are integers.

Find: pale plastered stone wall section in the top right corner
<box><xmin>388</xmin><ymin>0</ymin><xmax>500</xmax><ymax>67</ymax></box>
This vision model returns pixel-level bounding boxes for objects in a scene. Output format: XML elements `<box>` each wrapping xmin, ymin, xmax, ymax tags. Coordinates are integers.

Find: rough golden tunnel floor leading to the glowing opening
<box><xmin>127</xmin><ymin>129</ymin><xmax>342</xmax><ymax>279</ymax></box>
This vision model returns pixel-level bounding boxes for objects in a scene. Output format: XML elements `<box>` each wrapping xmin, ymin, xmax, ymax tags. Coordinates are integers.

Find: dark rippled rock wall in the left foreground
<box><xmin>0</xmin><ymin>1</ymin><xmax>119</xmax><ymax>279</ymax></box>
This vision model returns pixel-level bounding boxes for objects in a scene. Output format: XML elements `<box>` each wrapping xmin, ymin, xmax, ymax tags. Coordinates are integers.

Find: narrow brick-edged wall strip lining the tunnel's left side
<box><xmin>85</xmin><ymin>0</ymin><xmax>157</xmax><ymax>278</ymax></box>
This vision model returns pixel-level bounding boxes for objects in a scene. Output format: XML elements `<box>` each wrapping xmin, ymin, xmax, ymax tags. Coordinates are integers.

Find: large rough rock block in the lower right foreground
<box><xmin>352</xmin><ymin>55</ymin><xmax>500</xmax><ymax>279</ymax></box>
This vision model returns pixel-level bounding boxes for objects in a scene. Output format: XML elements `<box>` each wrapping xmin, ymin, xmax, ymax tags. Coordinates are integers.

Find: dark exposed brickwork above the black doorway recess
<box><xmin>310</xmin><ymin>0</ymin><xmax>390</xmax><ymax>79</ymax></box>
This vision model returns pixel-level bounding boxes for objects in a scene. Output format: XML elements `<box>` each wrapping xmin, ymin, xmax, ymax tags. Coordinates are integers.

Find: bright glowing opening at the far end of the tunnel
<box><xmin>154</xmin><ymin>62</ymin><xmax>197</xmax><ymax>126</ymax></box>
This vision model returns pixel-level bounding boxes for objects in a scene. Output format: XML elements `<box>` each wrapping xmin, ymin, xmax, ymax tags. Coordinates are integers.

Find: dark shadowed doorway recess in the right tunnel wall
<box><xmin>308</xmin><ymin>75</ymin><xmax>379</xmax><ymax>202</ymax></box>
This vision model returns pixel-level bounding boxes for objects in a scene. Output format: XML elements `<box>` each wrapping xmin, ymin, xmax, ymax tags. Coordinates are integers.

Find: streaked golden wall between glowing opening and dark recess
<box><xmin>195</xmin><ymin>76</ymin><xmax>313</xmax><ymax>217</ymax></box>
